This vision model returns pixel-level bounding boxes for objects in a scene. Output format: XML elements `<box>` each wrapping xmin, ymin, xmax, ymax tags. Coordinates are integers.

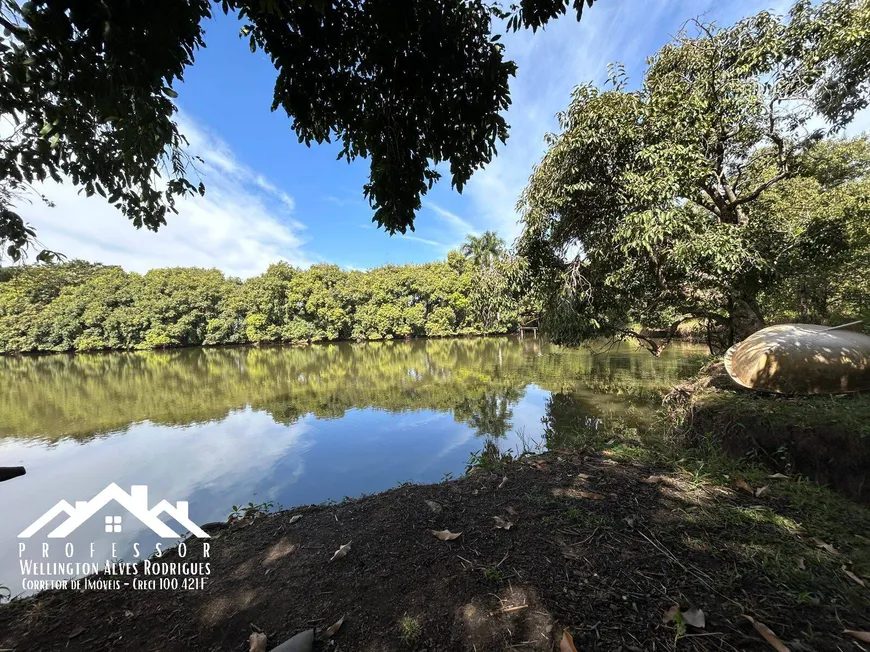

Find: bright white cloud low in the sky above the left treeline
<box><xmin>21</xmin><ymin>115</ymin><xmax>311</xmax><ymax>277</ymax></box>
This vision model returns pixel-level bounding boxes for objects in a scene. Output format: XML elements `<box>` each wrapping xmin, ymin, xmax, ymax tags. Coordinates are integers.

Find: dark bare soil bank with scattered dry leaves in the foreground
<box><xmin>0</xmin><ymin>452</ymin><xmax>870</xmax><ymax>652</ymax></box>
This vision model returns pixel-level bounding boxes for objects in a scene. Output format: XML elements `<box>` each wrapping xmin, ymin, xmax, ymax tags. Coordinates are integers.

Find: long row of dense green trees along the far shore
<box><xmin>0</xmin><ymin>242</ymin><xmax>517</xmax><ymax>352</ymax></box>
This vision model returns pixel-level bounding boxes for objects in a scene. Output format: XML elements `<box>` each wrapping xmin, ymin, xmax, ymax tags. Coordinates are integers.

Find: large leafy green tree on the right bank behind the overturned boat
<box><xmin>519</xmin><ymin>0</ymin><xmax>870</xmax><ymax>351</ymax></box>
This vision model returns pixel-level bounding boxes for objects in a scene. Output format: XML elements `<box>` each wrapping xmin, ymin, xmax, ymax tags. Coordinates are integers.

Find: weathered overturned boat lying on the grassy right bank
<box><xmin>725</xmin><ymin>322</ymin><xmax>870</xmax><ymax>394</ymax></box>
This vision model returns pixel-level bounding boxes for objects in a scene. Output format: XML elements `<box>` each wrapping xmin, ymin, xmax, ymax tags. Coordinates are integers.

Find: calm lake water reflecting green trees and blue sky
<box><xmin>0</xmin><ymin>337</ymin><xmax>706</xmax><ymax>594</ymax></box>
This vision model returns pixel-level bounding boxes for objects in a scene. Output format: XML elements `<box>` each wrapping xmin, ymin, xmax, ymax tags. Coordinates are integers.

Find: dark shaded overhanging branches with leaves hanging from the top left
<box><xmin>0</xmin><ymin>0</ymin><xmax>594</xmax><ymax>260</ymax></box>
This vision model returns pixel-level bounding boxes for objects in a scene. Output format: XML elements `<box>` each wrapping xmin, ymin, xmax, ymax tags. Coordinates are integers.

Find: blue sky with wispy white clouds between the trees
<box><xmin>26</xmin><ymin>0</ymin><xmax>867</xmax><ymax>277</ymax></box>
